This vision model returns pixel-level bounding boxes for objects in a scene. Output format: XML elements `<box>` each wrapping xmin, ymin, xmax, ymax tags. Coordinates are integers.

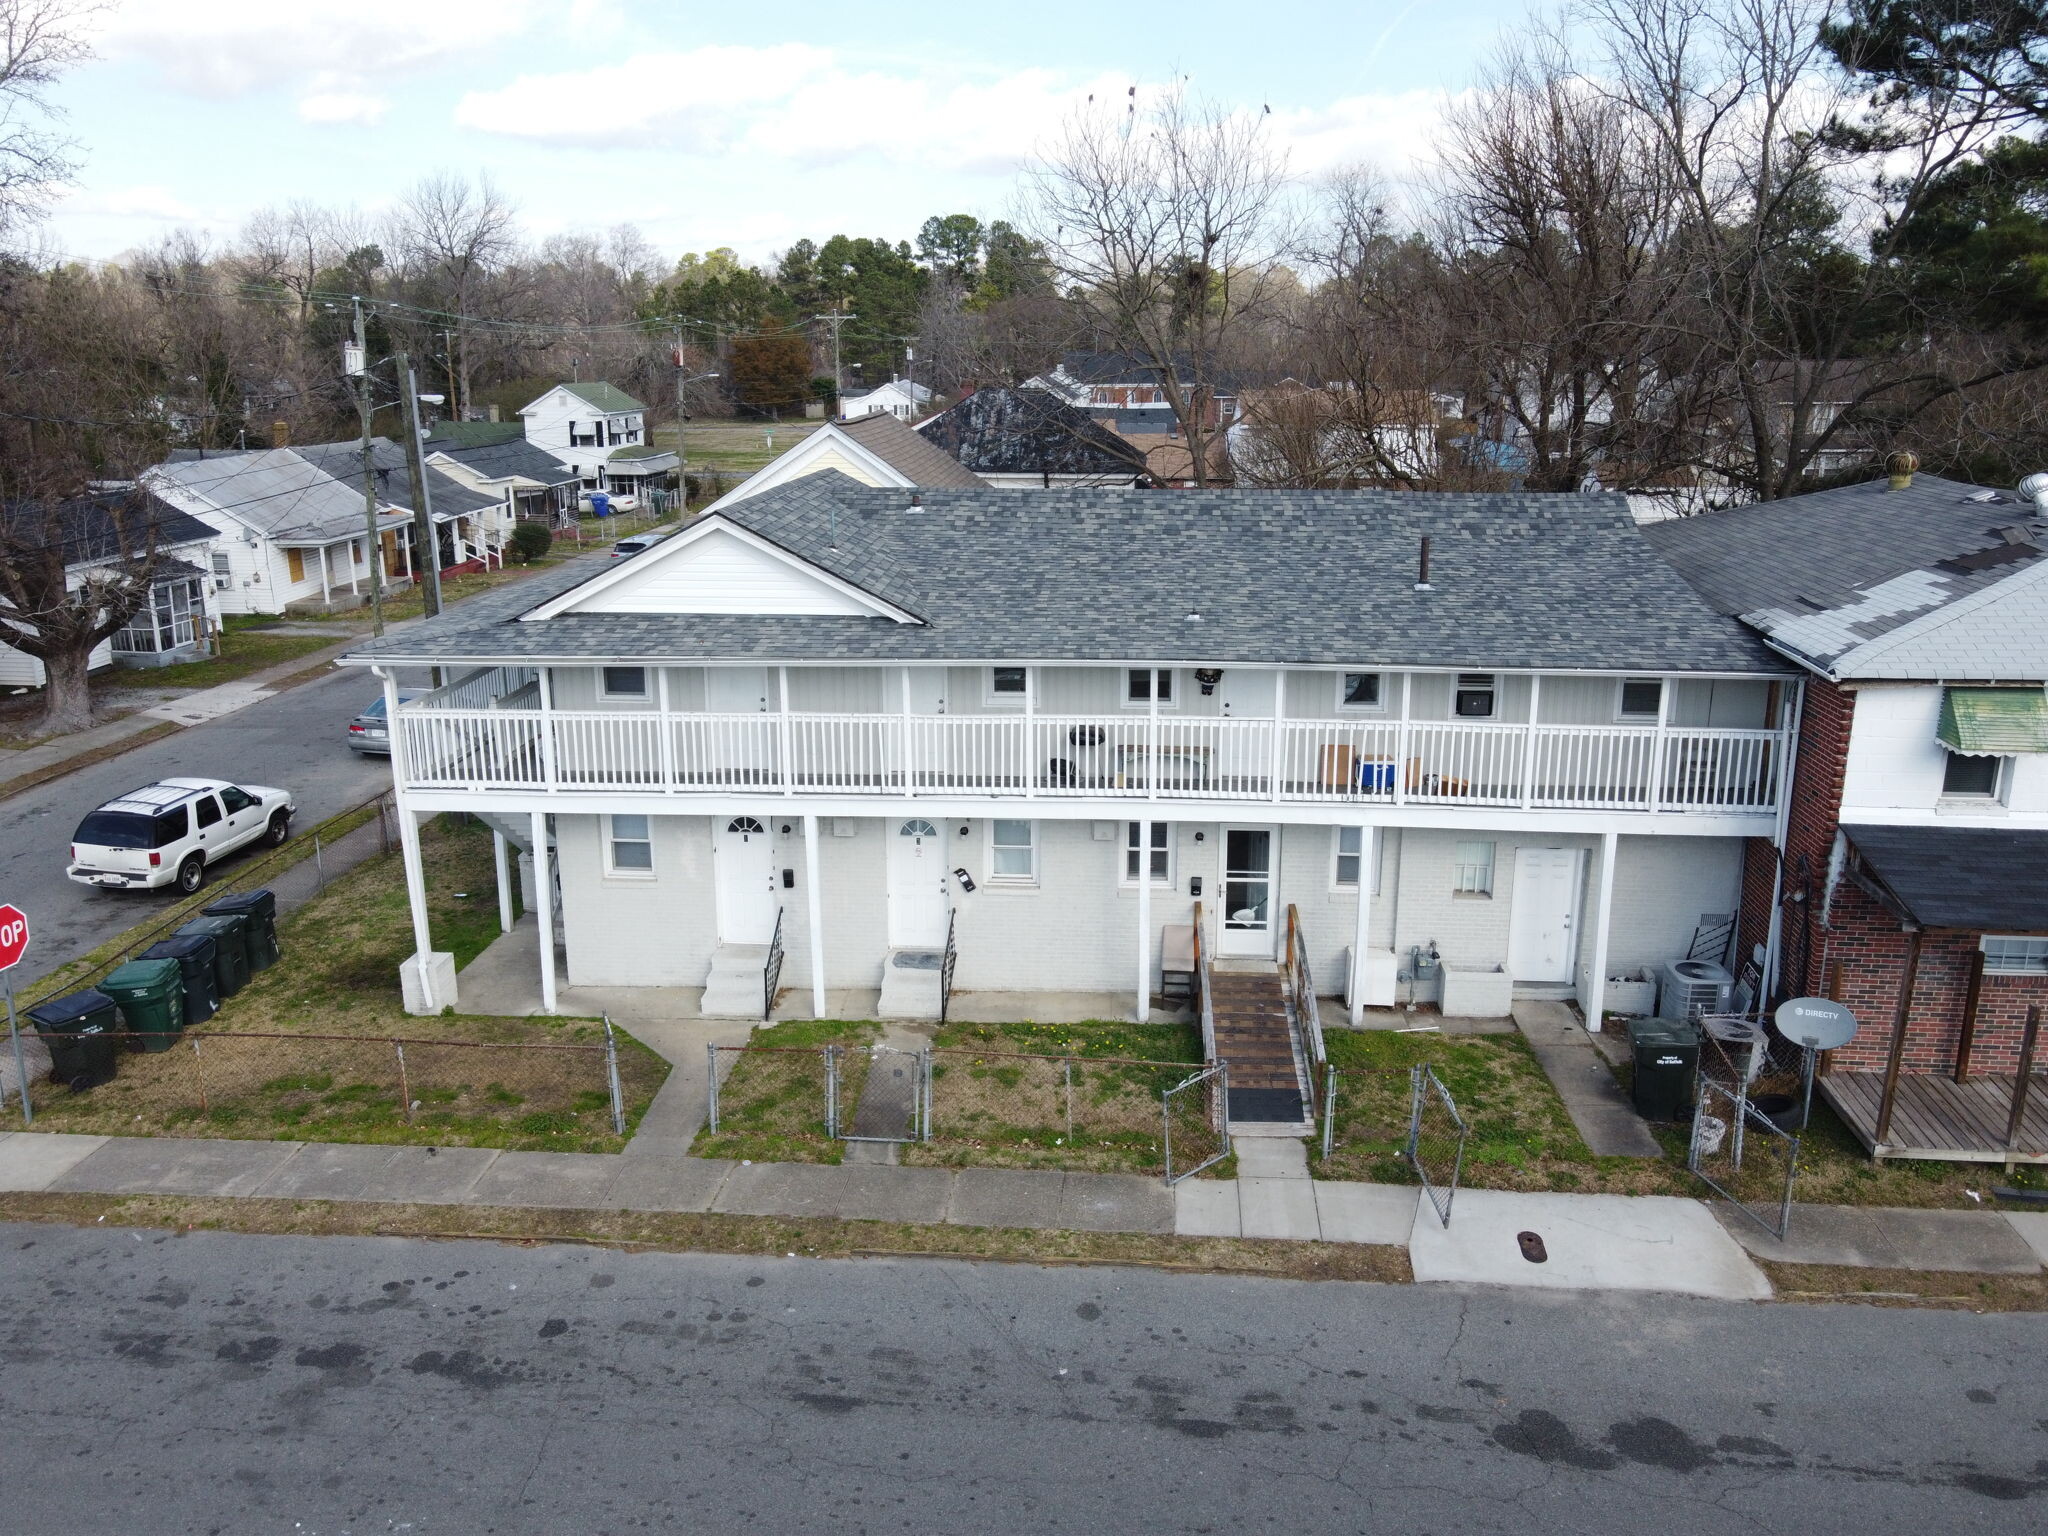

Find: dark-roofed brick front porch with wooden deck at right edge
<box><xmin>1817</xmin><ymin>827</ymin><xmax>2048</xmax><ymax>1167</ymax></box>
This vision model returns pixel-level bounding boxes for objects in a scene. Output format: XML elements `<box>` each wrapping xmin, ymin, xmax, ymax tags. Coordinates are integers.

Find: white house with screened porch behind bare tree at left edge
<box><xmin>0</xmin><ymin>498</ymin><xmax>219</xmax><ymax>688</ymax></box>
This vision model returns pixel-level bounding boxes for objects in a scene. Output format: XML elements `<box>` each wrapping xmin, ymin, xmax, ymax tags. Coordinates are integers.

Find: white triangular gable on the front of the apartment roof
<box><xmin>526</xmin><ymin>505</ymin><xmax>918</xmax><ymax>625</ymax></box>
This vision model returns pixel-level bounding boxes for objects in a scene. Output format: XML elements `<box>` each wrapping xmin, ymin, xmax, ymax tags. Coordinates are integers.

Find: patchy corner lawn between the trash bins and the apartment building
<box><xmin>24</xmin><ymin>819</ymin><xmax>668</xmax><ymax>1151</ymax></box>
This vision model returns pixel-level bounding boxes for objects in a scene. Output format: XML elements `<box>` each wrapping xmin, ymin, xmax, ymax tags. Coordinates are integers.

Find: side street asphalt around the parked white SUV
<box><xmin>0</xmin><ymin>668</ymin><xmax>415</xmax><ymax>991</ymax></box>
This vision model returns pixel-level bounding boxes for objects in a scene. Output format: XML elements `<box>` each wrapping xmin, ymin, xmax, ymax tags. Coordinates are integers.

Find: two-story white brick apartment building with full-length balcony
<box><xmin>346</xmin><ymin>471</ymin><xmax>1796</xmax><ymax>1040</ymax></box>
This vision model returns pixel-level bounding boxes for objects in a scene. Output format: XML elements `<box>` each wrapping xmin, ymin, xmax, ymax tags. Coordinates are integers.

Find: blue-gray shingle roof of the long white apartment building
<box><xmin>339</xmin><ymin>471</ymin><xmax>1786</xmax><ymax>674</ymax></box>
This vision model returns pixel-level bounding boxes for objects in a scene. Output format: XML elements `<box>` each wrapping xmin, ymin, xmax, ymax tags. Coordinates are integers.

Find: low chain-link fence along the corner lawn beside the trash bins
<box><xmin>16</xmin><ymin>1024</ymin><xmax>627</xmax><ymax>1149</ymax></box>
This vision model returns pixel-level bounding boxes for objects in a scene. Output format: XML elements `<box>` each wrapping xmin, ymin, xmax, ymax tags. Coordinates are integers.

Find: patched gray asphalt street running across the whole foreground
<box><xmin>0</xmin><ymin>1227</ymin><xmax>2048</xmax><ymax>1536</ymax></box>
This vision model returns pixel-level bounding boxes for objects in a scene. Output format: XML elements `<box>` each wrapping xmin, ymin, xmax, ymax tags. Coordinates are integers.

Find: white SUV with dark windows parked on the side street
<box><xmin>63</xmin><ymin>778</ymin><xmax>293</xmax><ymax>895</ymax></box>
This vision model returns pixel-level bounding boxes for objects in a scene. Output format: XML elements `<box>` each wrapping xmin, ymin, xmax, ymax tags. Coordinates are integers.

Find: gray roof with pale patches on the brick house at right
<box><xmin>1642</xmin><ymin>475</ymin><xmax>2048</xmax><ymax>678</ymax></box>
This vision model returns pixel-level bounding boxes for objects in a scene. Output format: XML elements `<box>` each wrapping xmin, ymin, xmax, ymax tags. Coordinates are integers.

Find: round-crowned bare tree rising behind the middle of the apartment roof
<box><xmin>1024</xmin><ymin>86</ymin><xmax>1286</xmax><ymax>485</ymax></box>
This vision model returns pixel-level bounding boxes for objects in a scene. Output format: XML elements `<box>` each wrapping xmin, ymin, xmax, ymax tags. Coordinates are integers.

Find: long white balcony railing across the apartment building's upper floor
<box><xmin>395</xmin><ymin>698</ymin><xmax>1784</xmax><ymax>813</ymax></box>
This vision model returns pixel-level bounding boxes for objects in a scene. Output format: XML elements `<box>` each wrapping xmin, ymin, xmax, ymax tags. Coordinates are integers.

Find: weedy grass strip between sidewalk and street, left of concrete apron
<box><xmin>0</xmin><ymin>1194</ymin><xmax>1413</xmax><ymax>1284</ymax></box>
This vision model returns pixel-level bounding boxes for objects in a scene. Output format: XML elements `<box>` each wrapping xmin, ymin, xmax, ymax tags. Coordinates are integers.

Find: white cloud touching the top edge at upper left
<box><xmin>96</xmin><ymin>0</ymin><xmax>552</xmax><ymax>98</ymax></box>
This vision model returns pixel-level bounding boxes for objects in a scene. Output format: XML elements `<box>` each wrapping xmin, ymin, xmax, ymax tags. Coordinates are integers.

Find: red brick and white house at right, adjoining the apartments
<box><xmin>1645</xmin><ymin>475</ymin><xmax>2048</xmax><ymax>1161</ymax></box>
